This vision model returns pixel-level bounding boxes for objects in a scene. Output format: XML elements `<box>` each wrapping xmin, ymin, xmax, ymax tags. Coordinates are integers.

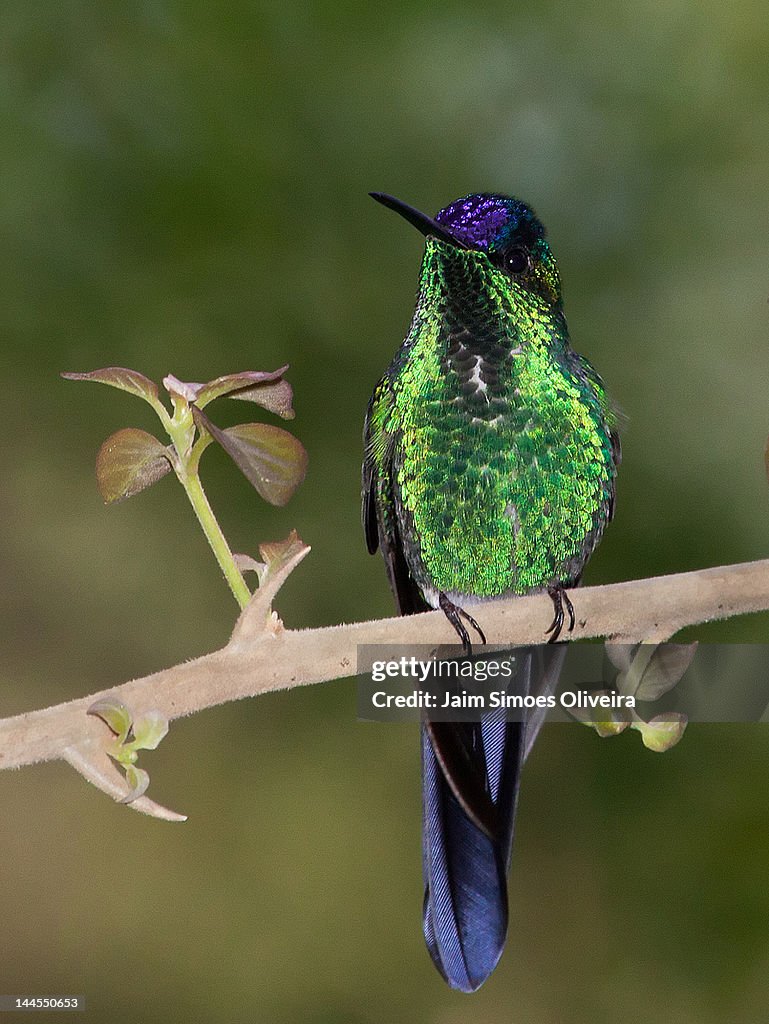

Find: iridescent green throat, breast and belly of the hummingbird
<box><xmin>375</xmin><ymin>241</ymin><xmax>616</xmax><ymax>603</ymax></box>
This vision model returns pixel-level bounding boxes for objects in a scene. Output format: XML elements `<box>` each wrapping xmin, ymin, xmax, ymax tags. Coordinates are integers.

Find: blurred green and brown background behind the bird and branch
<box><xmin>0</xmin><ymin>0</ymin><xmax>769</xmax><ymax>1024</ymax></box>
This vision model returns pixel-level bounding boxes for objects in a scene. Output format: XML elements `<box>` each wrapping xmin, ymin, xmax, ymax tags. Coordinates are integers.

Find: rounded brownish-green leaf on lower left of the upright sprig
<box><xmin>96</xmin><ymin>427</ymin><xmax>171</xmax><ymax>505</ymax></box>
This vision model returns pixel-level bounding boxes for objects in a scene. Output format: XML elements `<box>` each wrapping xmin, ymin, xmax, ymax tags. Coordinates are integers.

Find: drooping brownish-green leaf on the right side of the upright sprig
<box><xmin>193</xmin><ymin>407</ymin><xmax>307</xmax><ymax>505</ymax></box>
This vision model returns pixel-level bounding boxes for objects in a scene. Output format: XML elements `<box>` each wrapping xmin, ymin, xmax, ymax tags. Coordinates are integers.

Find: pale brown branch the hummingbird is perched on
<box><xmin>0</xmin><ymin>557</ymin><xmax>769</xmax><ymax>820</ymax></box>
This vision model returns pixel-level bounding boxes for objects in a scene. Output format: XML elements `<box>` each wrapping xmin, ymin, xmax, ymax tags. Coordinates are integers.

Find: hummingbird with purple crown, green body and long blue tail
<box><xmin>362</xmin><ymin>193</ymin><xmax>621</xmax><ymax>992</ymax></box>
